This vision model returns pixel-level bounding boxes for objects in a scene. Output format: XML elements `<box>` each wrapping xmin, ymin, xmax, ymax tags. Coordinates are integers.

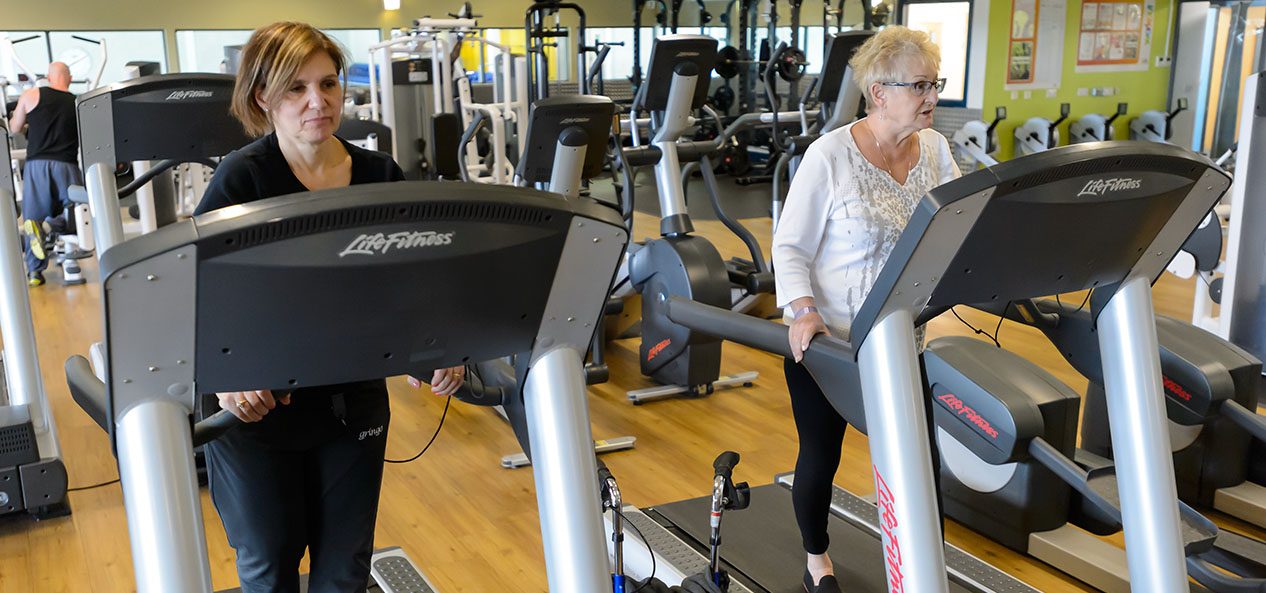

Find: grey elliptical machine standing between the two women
<box><xmin>619</xmin><ymin>35</ymin><xmax>774</xmax><ymax>403</ymax></box>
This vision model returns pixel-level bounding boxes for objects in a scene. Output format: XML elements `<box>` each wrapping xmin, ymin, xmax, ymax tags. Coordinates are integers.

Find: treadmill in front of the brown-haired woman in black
<box><xmin>67</xmin><ymin>79</ymin><xmax>628</xmax><ymax>593</ymax></box>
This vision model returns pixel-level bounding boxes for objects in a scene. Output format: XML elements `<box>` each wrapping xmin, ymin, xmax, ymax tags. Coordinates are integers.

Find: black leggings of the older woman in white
<box><xmin>782</xmin><ymin>356</ymin><xmax>944</xmax><ymax>554</ymax></box>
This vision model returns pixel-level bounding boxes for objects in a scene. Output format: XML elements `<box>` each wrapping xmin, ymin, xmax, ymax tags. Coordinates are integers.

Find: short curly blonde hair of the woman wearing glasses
<box><xmin>848</xmin><ymin>25</ymin><xmax>941</xmax><ymax>112</ymax></box>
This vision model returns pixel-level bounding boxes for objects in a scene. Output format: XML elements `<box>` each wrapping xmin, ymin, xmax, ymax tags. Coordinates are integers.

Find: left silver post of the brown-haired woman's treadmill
<box><xmin>116</xmin><ymin>400</ymin><xmax>211</xmax><ymax>593</ymax></box>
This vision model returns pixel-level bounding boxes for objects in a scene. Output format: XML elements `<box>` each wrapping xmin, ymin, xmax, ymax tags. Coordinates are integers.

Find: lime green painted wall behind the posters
<box><xmin>984</xmin><ymin>0</ymin><xmax>1174</xmax><ymax>158</ymax></box>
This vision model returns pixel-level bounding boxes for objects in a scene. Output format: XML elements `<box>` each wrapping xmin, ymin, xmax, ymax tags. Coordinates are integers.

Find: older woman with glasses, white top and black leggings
<box><xmin>772</xmin><ymin>27</ymin><xmax>960</xmax><ymax>593</ymax></box>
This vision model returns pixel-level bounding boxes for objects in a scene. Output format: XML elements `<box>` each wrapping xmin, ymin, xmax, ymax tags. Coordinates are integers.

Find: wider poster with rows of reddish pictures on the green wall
<box><xmin>1076</xmin><ymin>0</ymin><xmax>1156</xmax><ymax>72</ymax></box>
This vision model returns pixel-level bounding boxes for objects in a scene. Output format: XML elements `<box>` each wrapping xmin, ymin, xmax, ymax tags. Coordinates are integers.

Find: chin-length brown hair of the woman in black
<box><xmin>229</xmin><ymin>23</ymin><xmax>347</xmax><ymax>136</ymax></box>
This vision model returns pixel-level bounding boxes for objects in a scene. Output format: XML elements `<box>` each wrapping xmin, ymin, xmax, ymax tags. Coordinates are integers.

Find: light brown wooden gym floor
<box><xmin>0</xmin><ymin>210</ymin><xmax>1255</xmax><ymax>593</ymax></box>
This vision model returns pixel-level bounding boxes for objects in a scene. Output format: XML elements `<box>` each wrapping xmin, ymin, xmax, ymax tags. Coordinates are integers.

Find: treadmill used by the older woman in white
<box><xmin>617</xmin><ymin>142</ymin><xmax>1229</xmax><ymax>593</ymax></box>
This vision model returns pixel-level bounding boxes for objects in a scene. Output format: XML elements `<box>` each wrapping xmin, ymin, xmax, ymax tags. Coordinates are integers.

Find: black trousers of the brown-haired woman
<box><xmin>206</xmin><ymin>381</ymin><xmax>390</xmax><ymax>593</ymax></box>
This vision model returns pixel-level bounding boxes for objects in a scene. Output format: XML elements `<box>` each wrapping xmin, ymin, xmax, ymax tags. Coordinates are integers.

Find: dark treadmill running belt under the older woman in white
<box><xmin>651</xmin><ymin>484</ymin><xmax>968</xmax><ymax>593</ymax></box>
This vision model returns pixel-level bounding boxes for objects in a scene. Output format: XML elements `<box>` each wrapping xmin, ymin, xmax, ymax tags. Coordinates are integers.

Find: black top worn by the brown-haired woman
<box><xmin>194</xmin><ymin>133</ymin><xmax>404</xmax><ymax>450</ymax></box>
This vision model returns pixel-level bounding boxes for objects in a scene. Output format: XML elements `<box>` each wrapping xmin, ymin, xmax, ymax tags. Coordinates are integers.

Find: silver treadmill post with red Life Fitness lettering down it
<box><xmin>857</xmin><ymin>309</ymin><xmax>948</xmax><ymax>593</ymax></box>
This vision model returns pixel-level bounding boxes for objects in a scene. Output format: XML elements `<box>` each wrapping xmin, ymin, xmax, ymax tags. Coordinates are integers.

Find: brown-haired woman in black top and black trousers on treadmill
<box><xmin>196</xmin><ymin>23</ymin><xmax>462</xmax><ymax>593</ymax></box>
